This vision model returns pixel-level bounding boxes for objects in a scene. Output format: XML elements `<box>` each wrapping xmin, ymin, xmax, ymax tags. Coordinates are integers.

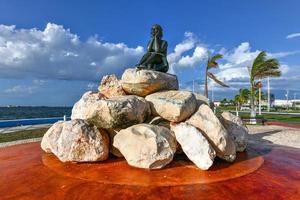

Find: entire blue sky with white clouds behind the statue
<box><xmin>0</xmin><ymin>0</ymin><xmax>300</xmax><ymax>106</ymax></box>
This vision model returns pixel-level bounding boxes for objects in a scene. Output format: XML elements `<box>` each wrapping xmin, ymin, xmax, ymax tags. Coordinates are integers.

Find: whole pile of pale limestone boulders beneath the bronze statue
<box><xmin>41</xmin><ymin>68</ymin><xmax>248</xmax><ymax>170</ymax></box>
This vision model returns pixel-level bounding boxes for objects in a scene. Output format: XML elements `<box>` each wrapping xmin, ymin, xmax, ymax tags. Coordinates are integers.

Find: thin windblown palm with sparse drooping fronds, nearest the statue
<box><xmin>205</xmin><ymin>54</ymin><xmax>229</xmax><ymax>98</ymax></box>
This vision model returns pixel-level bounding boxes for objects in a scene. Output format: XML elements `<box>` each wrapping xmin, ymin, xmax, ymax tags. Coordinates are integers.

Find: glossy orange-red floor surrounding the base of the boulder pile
<box><xmin>0</xmin><ymin>143</ymin><xmax>300</xmax><ymax>200</ymax></box>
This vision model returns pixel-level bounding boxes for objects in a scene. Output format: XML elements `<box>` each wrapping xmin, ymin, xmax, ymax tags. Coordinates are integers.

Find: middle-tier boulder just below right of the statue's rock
<box><xmin>146</xmin><ymin>90</ymin><xmax>197</xmax><ymax>122</ymax></box>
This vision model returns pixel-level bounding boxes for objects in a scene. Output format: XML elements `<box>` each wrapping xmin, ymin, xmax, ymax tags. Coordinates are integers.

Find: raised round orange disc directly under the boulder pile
<box><xmin>42</xmin><ymin>152</ymin><xmax>264</xmax><ymax>186</ymax></box>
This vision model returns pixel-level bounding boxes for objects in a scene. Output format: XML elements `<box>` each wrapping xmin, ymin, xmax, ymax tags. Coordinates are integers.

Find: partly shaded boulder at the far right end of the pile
<box><xmin>220</xmin><ymin>111</ymin><xmax>248</xmax><ymax>152</ymax></box>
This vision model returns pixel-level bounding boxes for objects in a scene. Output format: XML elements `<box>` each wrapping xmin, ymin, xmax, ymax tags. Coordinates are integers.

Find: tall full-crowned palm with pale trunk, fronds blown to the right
<box><xmin>249</xmin><ymin>51</ymin><xmax>281</xmax><ymax>124</ymax></box>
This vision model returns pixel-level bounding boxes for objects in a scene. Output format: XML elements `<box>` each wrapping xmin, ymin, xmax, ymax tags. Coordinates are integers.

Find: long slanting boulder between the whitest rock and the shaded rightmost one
<box><xmin>186</xmin><ymin>104</ymin><xmax>236</xmax><ymax>162</ymax></box>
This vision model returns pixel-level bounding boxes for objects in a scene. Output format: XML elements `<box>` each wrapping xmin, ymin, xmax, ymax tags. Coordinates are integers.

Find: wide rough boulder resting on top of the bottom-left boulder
<box><xmin>71</xmin><ymin>92</ymin><xmax>151</xmax><ymax>129</ymax></box>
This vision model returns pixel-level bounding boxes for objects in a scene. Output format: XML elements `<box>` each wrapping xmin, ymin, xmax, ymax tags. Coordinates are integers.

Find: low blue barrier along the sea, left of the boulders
<box><xmin>0</xmin><ymin>116</ymin><xmax>71</xmax><ymax>128</ymax></box>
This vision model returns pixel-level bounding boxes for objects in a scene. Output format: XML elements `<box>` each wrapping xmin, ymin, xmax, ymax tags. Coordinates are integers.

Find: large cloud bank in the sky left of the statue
<box><xmin>0</xmin><ymin>23</ymin><xmax>144</xmax><ymax>80</ymax></box>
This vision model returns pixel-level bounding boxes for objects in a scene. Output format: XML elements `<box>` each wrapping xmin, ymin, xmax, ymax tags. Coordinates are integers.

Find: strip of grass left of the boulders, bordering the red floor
<box><xmin>0</xmin><ymin>128</ymin><xmax>48</xmax><ymax>143</ymax></box>
